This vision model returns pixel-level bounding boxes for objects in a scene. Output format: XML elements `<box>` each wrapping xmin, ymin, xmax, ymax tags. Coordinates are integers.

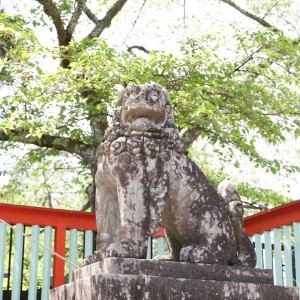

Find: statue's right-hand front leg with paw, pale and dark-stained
<box><xmin>106</xmin><ymin>152</ymin><xmax>151</xmax><ymax>258</ymax></box>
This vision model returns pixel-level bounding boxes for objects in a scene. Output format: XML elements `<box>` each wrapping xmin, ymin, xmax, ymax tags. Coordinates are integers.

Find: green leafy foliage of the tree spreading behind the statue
<box><xmin>0</xmin><ymin>1</ymin><xmax>300</xmax><ymax>210</ymax></box>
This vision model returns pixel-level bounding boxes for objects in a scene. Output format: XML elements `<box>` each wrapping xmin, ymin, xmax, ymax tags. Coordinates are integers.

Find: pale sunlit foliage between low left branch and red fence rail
<box><xmin>0</xmin><ymin>148</ymin><xmax>91</xmax><ymax>210</ymax></box>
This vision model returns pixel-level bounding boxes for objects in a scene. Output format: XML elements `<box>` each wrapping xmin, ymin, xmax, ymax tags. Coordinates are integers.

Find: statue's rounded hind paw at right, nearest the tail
<box><xmin>180</xmin><ymin>246</ymin><xmax>217</xmax><ymax>264</ymax></box>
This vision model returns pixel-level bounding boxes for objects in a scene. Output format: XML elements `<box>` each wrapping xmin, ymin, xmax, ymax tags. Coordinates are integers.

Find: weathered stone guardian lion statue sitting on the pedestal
<box><xmin>83</xmin><ymin>83</ymin><xmax>256</xmax><ymax>267</ymax></box>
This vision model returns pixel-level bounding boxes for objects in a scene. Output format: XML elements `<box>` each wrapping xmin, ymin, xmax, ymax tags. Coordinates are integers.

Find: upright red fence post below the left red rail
<box><xmin>53</xmin><ymin>225</ymin><xmax>66</xmax><ymax>287</ymax></box>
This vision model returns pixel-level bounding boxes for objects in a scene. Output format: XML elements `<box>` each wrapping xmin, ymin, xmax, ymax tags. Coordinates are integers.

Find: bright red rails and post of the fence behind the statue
<box><xmin>0</xmin><ymin>200</ymin><xmax>300</xmax><ymax>287</ymax></box>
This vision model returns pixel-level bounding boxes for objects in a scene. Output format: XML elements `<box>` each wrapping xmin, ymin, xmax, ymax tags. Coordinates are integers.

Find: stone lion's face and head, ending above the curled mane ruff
<box><xmin>105</xmin><ymin>83</ymin><xmax>179</xmax><ymax>141</ymax></box>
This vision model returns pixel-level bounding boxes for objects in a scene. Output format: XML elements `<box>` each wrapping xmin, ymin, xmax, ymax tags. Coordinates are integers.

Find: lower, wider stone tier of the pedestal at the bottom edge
<box><xmin>49</xmin><ymin>273</ymin><xmax>299</xmax><ymax>300</ymax></box>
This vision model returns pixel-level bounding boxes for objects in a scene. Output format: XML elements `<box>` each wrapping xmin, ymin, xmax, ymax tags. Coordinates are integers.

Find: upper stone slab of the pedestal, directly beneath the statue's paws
<box><xmin>71</xmin><ymin>257</ymin><xmax>273</xmax><ymax>284</ymax></box>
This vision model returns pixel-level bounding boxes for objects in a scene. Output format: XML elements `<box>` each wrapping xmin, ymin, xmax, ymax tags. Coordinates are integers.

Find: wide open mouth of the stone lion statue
<box><xmin>124</xmin><ymin>106</ymin><xmax>166</xmax><ymax>125</ymax></box>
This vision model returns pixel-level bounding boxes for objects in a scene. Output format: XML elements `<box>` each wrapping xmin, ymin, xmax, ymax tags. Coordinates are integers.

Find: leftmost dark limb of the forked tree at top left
<box><xmin>36</xmin><ymin>0</ymin><xmax>66</xmax><ymax>46</ymax></box>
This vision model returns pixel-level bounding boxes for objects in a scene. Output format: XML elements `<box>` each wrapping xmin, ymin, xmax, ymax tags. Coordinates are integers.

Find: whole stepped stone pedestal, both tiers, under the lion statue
<box><xmin>49</xmin><ymin>258</ymin><xmax>299</xmax><ymax>300</ymax></box>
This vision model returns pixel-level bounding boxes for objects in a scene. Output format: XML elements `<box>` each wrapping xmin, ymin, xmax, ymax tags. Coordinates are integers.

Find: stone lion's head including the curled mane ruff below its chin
<box><xmin>97</xmin><ymin>83</ymin><xmax>187</xmax><ymax>159</ymax></box>
